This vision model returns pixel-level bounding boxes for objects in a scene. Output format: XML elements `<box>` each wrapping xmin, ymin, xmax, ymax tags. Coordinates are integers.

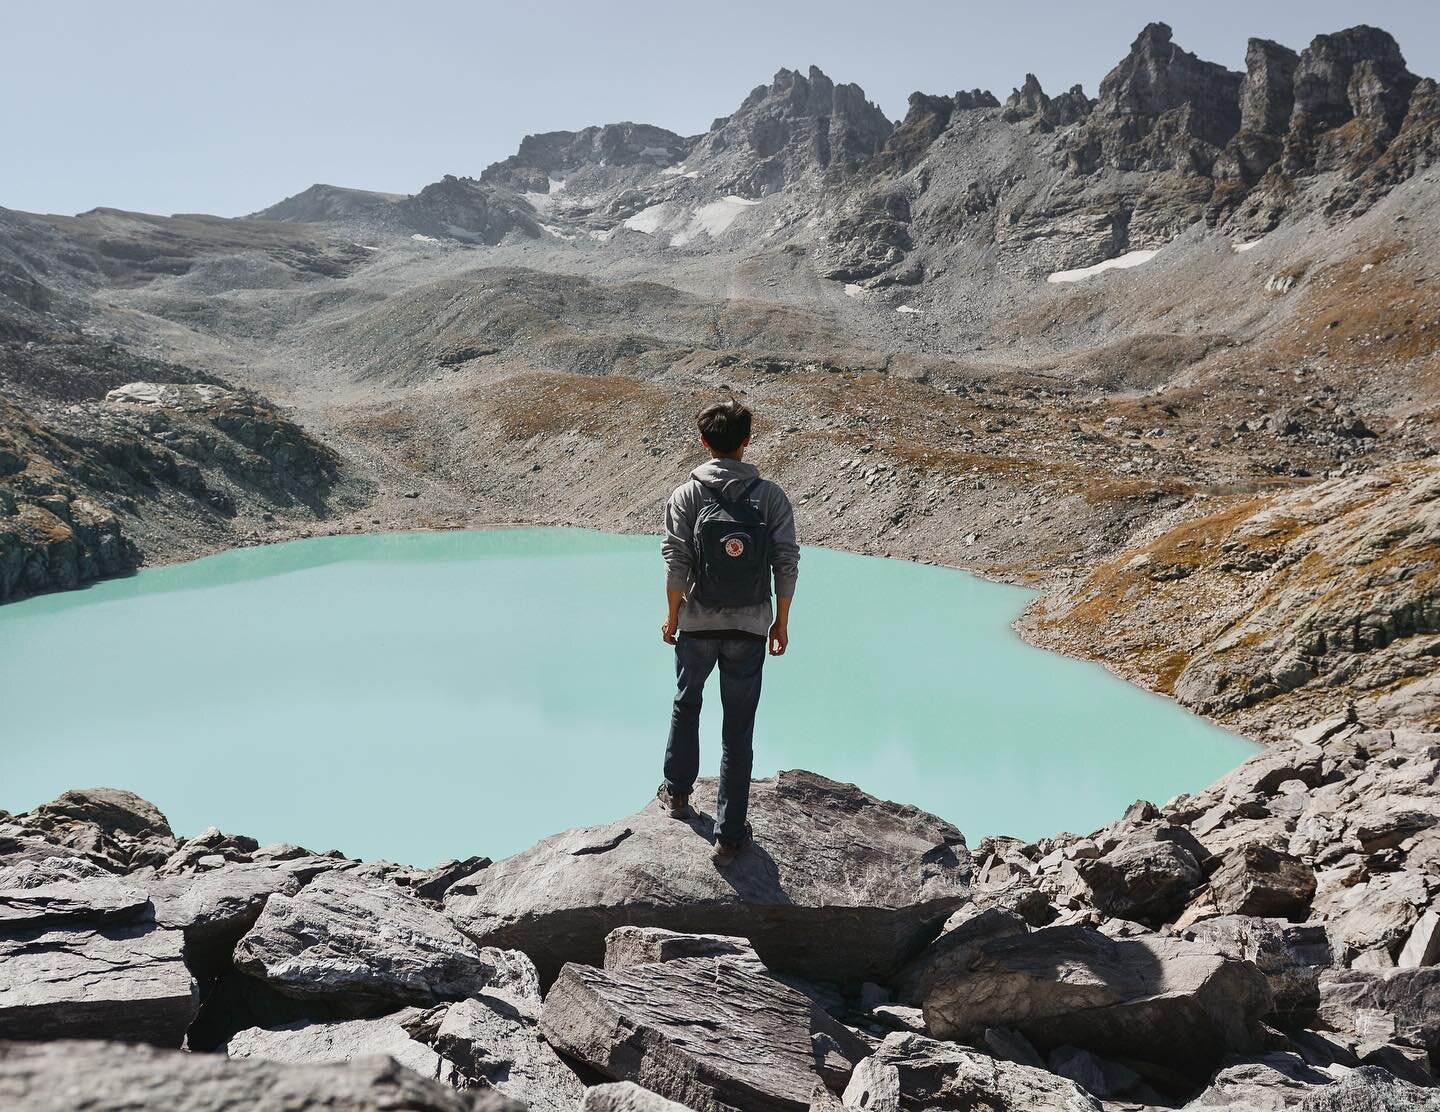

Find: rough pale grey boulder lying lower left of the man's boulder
<box><xmin>235</xmin><ymin>873</ymin><xmax>539</xmax><ymax>1014</ymax></box>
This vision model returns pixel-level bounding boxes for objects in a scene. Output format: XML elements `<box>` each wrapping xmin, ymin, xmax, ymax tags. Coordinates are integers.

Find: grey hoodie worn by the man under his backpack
<box><xmin>660</xmin><ymin>459</ymin><xmax>801</xmax><ymax>637</ymax></box>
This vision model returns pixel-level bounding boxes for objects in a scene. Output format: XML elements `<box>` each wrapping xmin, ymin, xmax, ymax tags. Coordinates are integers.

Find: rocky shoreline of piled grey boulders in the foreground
<box><xmin>0</xmin><ymin>719</ymin><xmax>1440</xmax><ymax>1112</ymax></box>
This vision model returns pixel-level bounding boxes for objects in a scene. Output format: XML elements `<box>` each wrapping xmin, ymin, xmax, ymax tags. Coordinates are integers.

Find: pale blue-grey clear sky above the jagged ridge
<box><xmin>0</xmin><ymin>0</ymin><xmax>1440</xmax><ymax>216</ymax></box>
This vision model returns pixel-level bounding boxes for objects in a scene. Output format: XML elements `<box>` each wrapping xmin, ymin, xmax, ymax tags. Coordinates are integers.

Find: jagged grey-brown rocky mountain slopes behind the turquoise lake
<box><xmin>0</xmin><ymin>23</ymin><xmax>1440</xmax><ymax>733</ymax></box>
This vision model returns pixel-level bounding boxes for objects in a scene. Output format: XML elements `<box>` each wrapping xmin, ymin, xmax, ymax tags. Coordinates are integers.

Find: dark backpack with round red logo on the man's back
<box><xmin>694</xmin><ymin>478</ymin><xmax>770</xmax><ymax>608</ymax></box>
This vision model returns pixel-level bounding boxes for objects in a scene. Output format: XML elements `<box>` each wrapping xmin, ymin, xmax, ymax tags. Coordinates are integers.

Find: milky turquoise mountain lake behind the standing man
<box><xmin>0</xmin><ymin>529</ymin><xmax>1254</xmax><ymax>866</ymax></box>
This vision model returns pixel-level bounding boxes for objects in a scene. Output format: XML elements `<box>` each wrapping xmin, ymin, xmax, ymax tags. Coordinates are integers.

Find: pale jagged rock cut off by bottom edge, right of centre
<box><xmin>844</xmin><ymin>1031</ymin><xmax>1100</xmax><ymax>1112</ymax></box>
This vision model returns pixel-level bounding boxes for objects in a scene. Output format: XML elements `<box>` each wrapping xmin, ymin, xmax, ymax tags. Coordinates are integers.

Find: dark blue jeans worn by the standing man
<box><xmin>665</xmin><ymin>634</ymin><xmax>765</xmax><ymax>841</ymax></box>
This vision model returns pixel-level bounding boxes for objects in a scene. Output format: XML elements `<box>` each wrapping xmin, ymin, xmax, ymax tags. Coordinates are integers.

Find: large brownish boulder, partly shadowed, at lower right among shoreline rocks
<box><xmin>920</xmin><ymin>926</ymin><xmax>1272</xmax><ymax>1080</ymax></box>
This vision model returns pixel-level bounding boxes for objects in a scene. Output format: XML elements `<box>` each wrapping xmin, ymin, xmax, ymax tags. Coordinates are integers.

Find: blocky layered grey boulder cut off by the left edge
<box><xmin>0</xmin><ymin>919</ymin><xmax>199</xmax><ymax>1047</ymax></box>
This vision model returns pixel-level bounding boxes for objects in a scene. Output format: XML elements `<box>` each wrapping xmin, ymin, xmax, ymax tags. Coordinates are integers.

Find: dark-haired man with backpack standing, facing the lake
<box><xmin>660</xmin><ymin>399</ymin><xmax>801</xmax><ymax>866</ymax></box>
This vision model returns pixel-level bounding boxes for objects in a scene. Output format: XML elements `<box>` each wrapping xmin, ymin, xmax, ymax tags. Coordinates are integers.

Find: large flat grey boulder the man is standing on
<box><xmin>445</xmin><ymin>772</ymin><xmax>971</xmax><ymax>982</ymax></box>
